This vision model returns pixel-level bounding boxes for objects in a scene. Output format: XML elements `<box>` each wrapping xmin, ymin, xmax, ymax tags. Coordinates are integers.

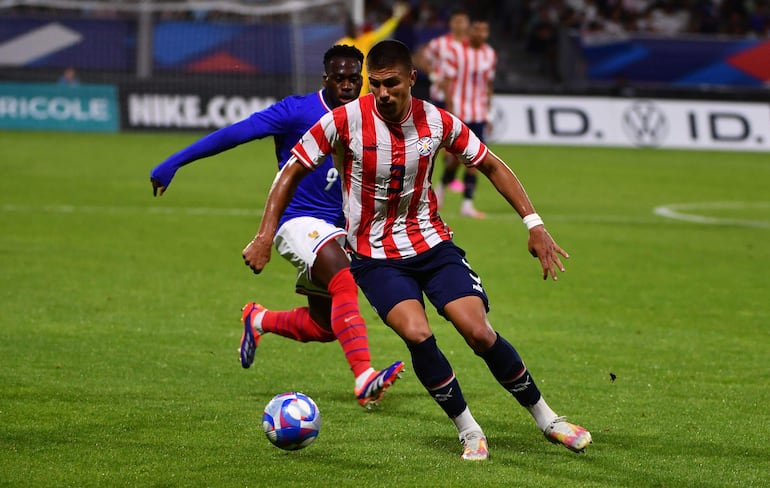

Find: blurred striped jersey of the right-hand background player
<box><xmin>443</xmin><ymin>44</ymin><xmax>497</xmax><ymax>123</ymax></box>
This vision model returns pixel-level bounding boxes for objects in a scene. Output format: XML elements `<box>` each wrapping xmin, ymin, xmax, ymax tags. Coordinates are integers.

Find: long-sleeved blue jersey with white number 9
<box><xmin>150</xmin><ymin>90</ymin><xmax>345</xmax><ymax>227</ymax></box>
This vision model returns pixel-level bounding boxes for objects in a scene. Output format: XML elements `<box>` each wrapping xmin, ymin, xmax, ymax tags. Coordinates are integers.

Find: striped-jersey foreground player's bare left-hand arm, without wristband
<box><xmin>243</xmin><ymin>156</ymin><xmax>310</xmax><ymax>274</ymax></box>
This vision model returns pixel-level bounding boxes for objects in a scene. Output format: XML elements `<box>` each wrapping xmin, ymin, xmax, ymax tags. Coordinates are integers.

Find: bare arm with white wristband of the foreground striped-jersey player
<box><xmin>478</xmin><ymin>151</ymin><xmax>569</xmax><ymax>281</ymax></box>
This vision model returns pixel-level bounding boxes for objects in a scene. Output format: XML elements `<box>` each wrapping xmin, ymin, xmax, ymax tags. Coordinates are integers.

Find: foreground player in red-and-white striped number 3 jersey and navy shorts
<box><xmin>243</xmin><ymin>40</ymin><xmax>591</xmax><ymax>460</ymax></box>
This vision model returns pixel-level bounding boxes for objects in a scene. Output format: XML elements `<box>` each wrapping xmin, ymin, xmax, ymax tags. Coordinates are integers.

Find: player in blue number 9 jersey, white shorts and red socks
<box><xmin>150</xmin><ymin>45</ymin><xmax>404</xmax><ymax>408</ymax></box>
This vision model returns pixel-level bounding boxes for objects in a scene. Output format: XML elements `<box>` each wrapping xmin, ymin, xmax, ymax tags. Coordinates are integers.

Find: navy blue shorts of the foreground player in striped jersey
<box><xmin>350</xmin><ymin>241</ymin><xmax>489</xmax><ymax>322</ymax></box>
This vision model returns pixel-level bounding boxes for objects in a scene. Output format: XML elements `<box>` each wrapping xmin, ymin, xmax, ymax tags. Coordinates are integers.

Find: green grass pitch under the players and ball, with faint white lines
<box><xmin>0</xmin><ymin>132</ymin><xmax>770</xmax><ymax>487</ymax></box>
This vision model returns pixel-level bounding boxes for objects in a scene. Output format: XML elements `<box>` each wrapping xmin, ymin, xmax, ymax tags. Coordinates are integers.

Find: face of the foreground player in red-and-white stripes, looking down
<box><xmin>369</xmin><ymin>65</ymin><xmax>417</xmax><ymax>123</ymax></box>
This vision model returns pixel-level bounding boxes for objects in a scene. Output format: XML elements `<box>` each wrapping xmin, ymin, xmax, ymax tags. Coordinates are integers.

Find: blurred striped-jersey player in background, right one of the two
<box><xmin>439</xmin><ymin>18</ymin><xmax>497</xmax><ymax>218</ymax></box>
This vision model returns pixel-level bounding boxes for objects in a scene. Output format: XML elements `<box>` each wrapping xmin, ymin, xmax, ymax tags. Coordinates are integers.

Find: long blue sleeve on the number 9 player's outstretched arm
<box><xmin>150</xmin><ymin>100</ymin><xmax>288</xmax><ymax>187</ymax></box>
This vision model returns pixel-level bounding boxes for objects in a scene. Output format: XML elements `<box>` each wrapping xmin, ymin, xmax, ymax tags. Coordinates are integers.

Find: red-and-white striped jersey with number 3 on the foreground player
<box><xmin>292</xmin><ymin>94</ymin><xmax>488</xmax><ymax>259</ymax></box>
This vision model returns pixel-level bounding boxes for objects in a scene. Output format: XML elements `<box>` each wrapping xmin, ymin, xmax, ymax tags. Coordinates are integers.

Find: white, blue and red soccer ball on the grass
<box><xmin>262</xmin><ymin>391</ymin><xmax>321</xmax><ymax>451</ymax></box>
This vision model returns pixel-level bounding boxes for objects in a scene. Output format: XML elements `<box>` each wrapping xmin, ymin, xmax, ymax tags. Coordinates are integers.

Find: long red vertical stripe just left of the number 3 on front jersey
<box><xmin>356</xmin><ymin>97</ymin><xmax>377</xmax><ymax>256</ymax></box>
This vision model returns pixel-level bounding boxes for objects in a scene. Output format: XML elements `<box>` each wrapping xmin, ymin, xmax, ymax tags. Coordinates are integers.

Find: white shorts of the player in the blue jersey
<box><xmin>273</xmin><ymin>217</ymin><xmax>347</xmax><ymax>296</ymax></box>
